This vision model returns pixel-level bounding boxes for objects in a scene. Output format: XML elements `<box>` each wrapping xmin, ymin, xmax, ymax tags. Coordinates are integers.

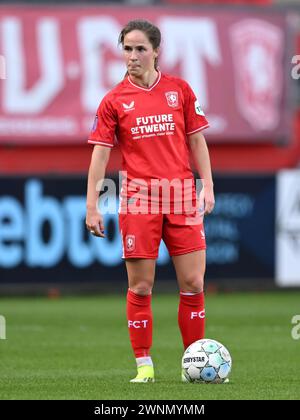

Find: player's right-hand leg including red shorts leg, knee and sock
<box><xmin>163</xmin><ymin>214</ymin><xmax>206</xmax><ymax>348</ymax></box>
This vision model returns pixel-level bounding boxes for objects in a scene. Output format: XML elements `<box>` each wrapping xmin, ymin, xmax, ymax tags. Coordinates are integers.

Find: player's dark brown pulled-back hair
<box><xmin>118</xmin><ymin>19</ymin><xmax>161</xmax><ymax>69</ymax></box>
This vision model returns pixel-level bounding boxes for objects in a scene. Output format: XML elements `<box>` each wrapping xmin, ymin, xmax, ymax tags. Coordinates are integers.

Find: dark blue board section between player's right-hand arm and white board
<box><xmin>205</xmin><ymin>176</ymin><xmax>275</xmax><ymax>280</ymax></box>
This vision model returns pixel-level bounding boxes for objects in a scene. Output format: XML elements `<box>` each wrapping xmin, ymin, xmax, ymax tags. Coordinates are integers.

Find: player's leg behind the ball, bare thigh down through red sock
<box><xmin>172</xmin><ymin>250</ymin><xmax>205</xmax><ymax>349</ymax></box>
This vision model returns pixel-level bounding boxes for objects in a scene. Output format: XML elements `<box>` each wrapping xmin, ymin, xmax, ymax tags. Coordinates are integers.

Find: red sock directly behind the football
<box><xmin>178</xmin><ymin>292</ymin><xmax>205</xmax><ymax>349</ymax></box>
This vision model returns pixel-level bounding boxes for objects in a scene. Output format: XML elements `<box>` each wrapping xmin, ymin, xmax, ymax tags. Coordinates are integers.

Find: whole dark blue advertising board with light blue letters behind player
<box><xmin>0</xmin><ymin>176</ymin><xmax>275</xmax><ymax>284</ymax></box>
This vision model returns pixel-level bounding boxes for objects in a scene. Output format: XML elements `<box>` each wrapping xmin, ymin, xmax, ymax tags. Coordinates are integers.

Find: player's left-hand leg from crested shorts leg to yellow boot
<box><xmin>119</xmin><ymin>214</ymin><xmax>162</xmax><ymax>382</ymax></box>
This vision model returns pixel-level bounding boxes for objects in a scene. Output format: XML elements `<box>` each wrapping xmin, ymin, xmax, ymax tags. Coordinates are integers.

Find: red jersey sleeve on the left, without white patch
<box><xmin>88</xmin><ymin>97</ymin><xmax>117</xmax><ymax>147</ymax></box>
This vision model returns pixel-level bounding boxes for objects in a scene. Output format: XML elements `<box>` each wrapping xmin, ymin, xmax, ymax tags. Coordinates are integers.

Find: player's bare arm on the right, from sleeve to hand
<box><xmin>189</xmin><ymin>131</ymin><xmax>215</xmax><ymax>214</ymax></box>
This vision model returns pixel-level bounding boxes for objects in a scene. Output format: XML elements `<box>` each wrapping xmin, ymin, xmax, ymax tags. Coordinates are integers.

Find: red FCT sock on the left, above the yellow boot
<box><xmin>127</xmin><ymin>289</ymin><xmax>152</xmax><ymax>357</ymax></box>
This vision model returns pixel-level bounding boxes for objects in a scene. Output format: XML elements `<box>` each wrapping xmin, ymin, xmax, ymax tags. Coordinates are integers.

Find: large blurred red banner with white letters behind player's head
<box><xmin>0</xmin><ymin>6</ymin><xmax>295</xmax><ymax>144</ymax></box>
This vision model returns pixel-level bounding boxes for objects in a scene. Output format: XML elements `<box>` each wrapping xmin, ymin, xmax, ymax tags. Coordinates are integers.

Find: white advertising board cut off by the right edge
<box><xmin>276</xmin><ymin>169</ymin><xmax>300</xmax><ymax>287</ymax></box>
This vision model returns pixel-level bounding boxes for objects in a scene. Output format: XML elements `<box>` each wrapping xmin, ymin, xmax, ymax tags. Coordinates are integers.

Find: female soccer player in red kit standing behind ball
<box><xmin>86</xmin><ymin>20</ymin><xmax>214</xmax><ymax>383</ymax></box>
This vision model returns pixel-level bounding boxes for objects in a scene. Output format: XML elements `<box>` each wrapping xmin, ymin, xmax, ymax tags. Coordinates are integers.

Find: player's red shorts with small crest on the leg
<box><xmin>119</xmin><ymin>213</ymin><xmax>206</xmax><ymax>259</ymax></box>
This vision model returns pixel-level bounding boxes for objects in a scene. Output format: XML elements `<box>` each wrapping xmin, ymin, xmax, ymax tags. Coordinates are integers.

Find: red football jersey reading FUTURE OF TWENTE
<box><xmin>88</xmin><ymin>72</ymin><xmax>209</xmax><ymax>212</ymax></box>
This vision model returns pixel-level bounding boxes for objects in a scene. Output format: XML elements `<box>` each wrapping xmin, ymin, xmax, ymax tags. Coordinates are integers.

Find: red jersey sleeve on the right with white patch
<box><xmin>183</xmin><ymin>83</ymin><xmax>209</xmax><ymax>135</ymax></box>
